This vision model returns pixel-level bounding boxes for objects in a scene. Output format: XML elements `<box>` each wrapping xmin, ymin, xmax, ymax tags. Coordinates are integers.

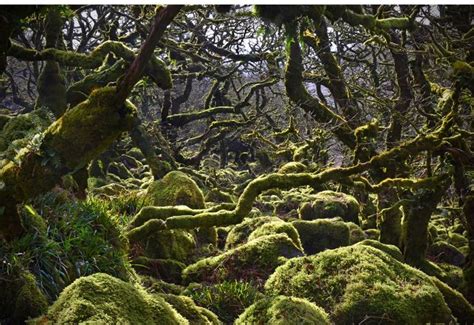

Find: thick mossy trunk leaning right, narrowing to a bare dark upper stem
<box><xmin>0</xmin><ymin>6</ymin><xmax>181</xmax><ymax>239</ymax></box>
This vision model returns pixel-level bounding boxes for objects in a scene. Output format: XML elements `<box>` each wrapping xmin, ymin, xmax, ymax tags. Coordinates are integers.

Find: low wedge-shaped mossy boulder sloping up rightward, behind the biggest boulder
<box><xmin>183</xmin><ymin>234</ymin><xmax>303</xmax><ymax>283</ymax></box>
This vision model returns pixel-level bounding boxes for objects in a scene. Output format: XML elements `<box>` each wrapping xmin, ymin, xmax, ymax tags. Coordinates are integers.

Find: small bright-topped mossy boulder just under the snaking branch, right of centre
<box><xmin>299</xmin><ymin>191</ymin><xmax>359</xmax><ymax>224</ymax></box>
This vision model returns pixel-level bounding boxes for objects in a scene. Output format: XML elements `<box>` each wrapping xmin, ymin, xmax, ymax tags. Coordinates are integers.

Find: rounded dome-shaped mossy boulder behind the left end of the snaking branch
<box><xmin>146</xmin><ymin>171</ymin><xmax>205</xmax><ymax>209</ymax></box>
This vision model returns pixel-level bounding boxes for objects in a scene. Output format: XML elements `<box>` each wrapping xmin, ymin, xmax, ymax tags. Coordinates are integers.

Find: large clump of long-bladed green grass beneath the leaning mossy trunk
<box><xmin>0</xmin><ymin>192</ymin><xmax>133</xmax><ymax>301</ymax></box>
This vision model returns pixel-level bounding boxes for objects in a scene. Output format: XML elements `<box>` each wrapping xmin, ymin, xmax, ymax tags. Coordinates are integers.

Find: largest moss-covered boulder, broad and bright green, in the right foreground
<box><xmin>265</xmin><ymin>244</ymin><xmax>452</xmax><ymax>324</ymax></box>
